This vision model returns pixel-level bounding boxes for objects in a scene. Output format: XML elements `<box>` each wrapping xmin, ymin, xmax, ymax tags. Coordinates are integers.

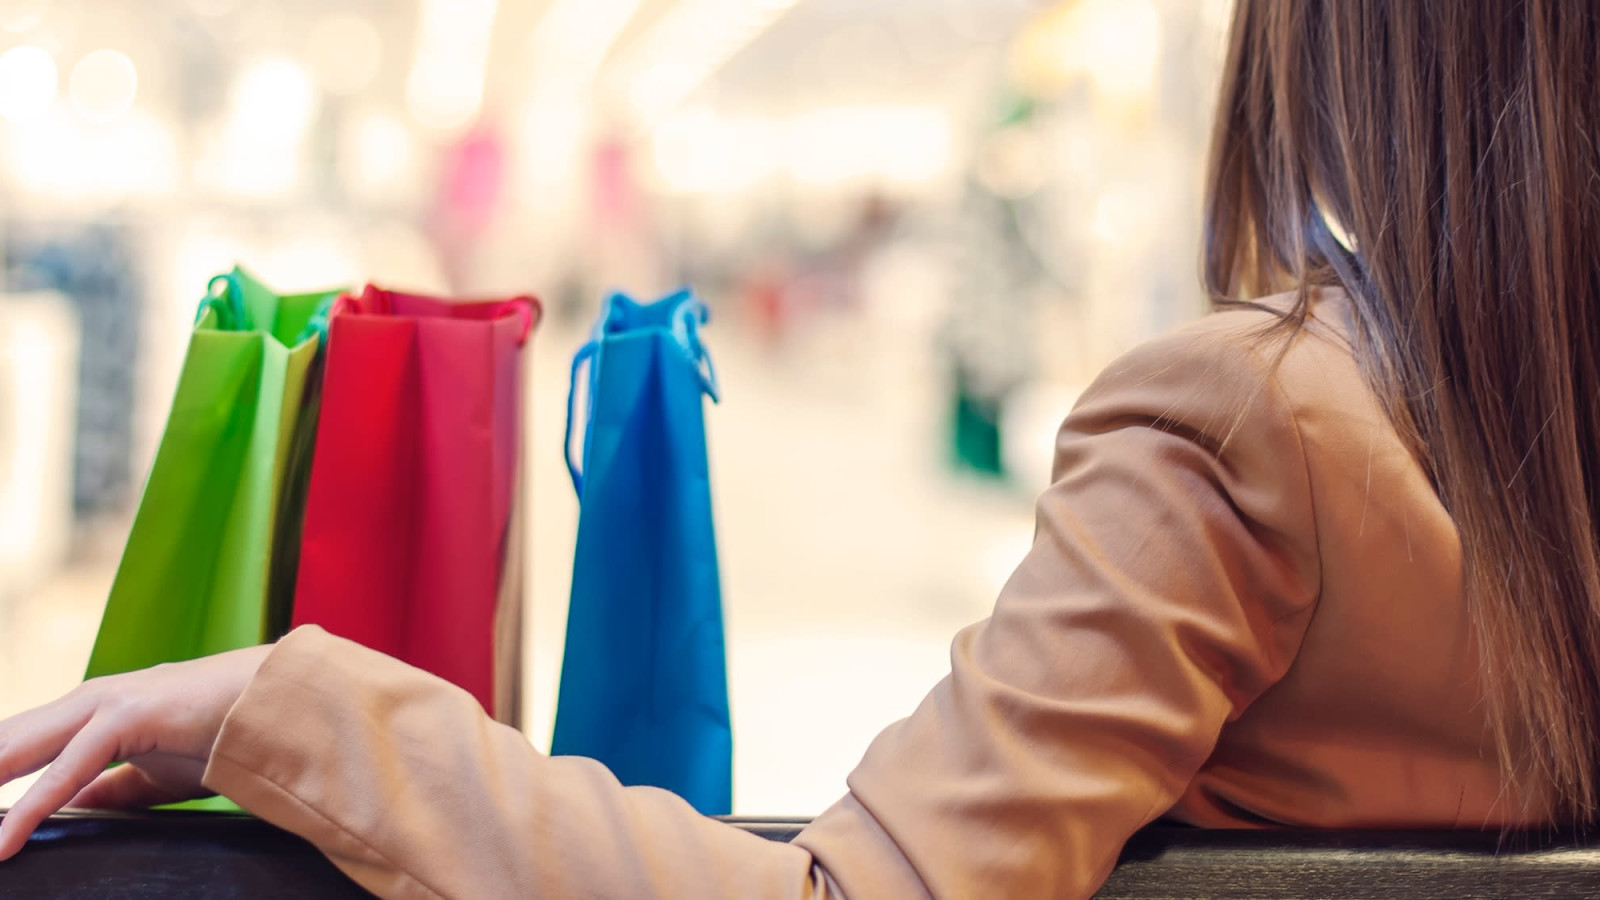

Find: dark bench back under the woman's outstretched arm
<box><xmin>0</xmin><ymin>812</ymin><xmax>1600</xmax><ymax>900</ymax></box>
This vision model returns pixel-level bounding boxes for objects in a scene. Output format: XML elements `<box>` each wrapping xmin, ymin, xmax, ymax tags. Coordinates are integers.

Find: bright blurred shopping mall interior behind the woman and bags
<box><xmin>0</xmin><ymin>0</ymin><xmax>1227</xmax><ymax>814</ymax></box>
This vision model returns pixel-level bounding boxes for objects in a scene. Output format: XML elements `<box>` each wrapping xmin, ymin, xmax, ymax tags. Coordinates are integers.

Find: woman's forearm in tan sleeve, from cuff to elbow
<box><xmin>205</xmin><ymin>628</ymin><xmax>813</xmax><ymax>898</ymax></box>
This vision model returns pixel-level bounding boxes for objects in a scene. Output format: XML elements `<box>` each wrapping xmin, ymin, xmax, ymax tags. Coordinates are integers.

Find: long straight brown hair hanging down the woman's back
<box><xmin>1205</xmin><ymin>0</ymin><xmax>1600</xmax><ymax>826</ymax></box>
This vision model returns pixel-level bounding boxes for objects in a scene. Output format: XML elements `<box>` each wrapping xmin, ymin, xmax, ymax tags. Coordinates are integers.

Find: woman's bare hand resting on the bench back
<box><xmin>0</xmin><ymin>647</ymin><xmax>272</xmax><ymax>860</ymax></box>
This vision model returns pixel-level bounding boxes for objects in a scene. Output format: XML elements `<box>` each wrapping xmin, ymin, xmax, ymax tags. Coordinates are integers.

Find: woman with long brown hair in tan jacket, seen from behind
<box><xmin>0</xmin><ymin>0</ymin><xmax>1600</xmax><ymax>898</ymax></box>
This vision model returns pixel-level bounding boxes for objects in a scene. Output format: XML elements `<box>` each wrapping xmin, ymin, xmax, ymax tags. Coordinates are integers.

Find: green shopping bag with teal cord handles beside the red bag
<box><xmin>88</xmin><ymin>267</ymin><xmax>339</xmax><ymax>677</ymax></box>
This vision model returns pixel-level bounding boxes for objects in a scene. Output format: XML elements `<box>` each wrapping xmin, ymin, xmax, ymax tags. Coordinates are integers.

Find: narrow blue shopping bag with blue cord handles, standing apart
<box><xmin>550</xmin><ymin>291</ymin><xmax>733</xmax><ymax>815</ymax></box>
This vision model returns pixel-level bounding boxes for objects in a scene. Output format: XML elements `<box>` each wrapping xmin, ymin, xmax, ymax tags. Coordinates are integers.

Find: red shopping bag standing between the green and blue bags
<box><xmin>293</xmin><ymin>287</ymin><xmax>541</xmax><ymax>724</ymax></box>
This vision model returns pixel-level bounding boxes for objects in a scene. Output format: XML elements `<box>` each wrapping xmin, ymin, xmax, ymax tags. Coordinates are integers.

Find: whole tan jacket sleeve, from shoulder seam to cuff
<box><xmin>205</xmin><ymin>317</ymin><xmax>1320</xmax><ymax>898</ymax></box>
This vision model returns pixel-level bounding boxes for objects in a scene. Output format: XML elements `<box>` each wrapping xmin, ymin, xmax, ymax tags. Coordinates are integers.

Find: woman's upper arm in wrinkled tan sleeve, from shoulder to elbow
<box><xmin>797</xmin><ymin>314</ymin><xmax>1322</xmax><ymax>897</ymax></box>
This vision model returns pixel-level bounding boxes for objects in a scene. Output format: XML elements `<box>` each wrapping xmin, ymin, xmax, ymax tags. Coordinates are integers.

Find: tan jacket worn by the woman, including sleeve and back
<box><xmin>196</xmin><ymin>291</ymin><xmax>1514</xmax><ymax>900</ymax></box>
